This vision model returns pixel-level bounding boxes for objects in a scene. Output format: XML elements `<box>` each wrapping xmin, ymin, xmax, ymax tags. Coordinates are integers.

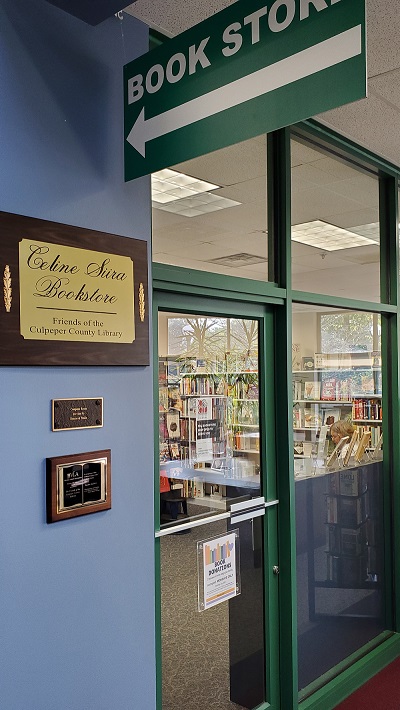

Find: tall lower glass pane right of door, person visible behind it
<box><xmin>292</xmin><ymin>304</ymin><xmax>385</xmax><ymax>690</ymax></box>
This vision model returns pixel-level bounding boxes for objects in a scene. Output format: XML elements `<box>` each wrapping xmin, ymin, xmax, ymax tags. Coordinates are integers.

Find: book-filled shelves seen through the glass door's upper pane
<box><xmin>159</xmin><ymin>358</ymin><xmax>260</xmax><ymax>509</ymax></box>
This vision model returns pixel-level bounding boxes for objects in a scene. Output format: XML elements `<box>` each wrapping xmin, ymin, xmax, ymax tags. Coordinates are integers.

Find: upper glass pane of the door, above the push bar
<box><xmin>159</xmin><ymin>313</ymin><xmax>260</xmax><ymax>526</ymax></box>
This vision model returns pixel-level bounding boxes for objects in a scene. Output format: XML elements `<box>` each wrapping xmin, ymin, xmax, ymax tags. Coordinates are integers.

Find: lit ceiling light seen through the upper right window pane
<box><xmin>292</xmin><ymin>219</ymin><xmax>377</xmax><ymax>251</ymax></box>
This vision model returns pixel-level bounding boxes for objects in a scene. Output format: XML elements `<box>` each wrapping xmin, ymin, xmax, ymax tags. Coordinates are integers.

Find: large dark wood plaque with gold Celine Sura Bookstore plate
<box><xmin>0</xmin><ymin>212</ymin><xmax>149</xmax><ymax>366</ymax></box>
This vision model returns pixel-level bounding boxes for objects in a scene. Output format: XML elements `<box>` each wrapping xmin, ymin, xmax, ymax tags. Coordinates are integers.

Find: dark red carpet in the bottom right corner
<box><xmin>336</xmin><ymin>658</ymin><xmax>400</xmax><ymax>710</ymax></box>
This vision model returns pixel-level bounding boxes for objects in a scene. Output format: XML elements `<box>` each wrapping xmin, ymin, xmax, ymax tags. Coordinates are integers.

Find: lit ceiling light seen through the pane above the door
<box><xmin>151</xmin><ymin>169</ymin><xmax>241</xmax><ymax>217</ymax></box>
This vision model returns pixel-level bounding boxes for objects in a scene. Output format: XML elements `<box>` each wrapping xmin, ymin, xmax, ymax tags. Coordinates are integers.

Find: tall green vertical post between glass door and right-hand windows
<box><xmin>267</xmin><ymin>128</ymin><xmax>298</xmax><ymax>708</ymax></box>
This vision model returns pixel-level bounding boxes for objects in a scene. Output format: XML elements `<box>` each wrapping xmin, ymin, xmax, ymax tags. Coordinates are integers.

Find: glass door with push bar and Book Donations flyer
<box><xmin>156</xmin><ymin>304</ymin><xmax>279</xmax><ymax>710</ymax></box>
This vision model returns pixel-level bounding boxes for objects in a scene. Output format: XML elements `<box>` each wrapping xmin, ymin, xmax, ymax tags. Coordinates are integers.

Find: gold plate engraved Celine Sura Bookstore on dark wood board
<box><xmin>19</xmin><ymin>239</ymin><xmax>135</xmax><ymax>343</ymax></box>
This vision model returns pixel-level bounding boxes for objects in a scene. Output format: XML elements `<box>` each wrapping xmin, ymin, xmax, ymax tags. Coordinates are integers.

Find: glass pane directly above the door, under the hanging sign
<box><xmin>152</xmin><ymin>136</ymin><xmax>268</xmax><ymax>281</ymax></box>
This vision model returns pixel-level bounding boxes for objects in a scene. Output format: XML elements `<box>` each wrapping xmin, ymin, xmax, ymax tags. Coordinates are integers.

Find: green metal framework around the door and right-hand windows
<box><xmin>153</xmin><ymin>120</ymin><xmax>400</xmax><ymax>710</ymax></box>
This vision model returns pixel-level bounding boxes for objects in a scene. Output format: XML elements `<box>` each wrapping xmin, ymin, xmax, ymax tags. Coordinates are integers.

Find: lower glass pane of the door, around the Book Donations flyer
<box><xmin>160</xmin><ymin>518</ymin><xmax>270</xmax><ymax>710</ymax></box>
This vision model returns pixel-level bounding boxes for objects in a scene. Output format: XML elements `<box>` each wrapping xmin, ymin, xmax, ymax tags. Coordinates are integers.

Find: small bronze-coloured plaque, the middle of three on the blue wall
<box><xmin>52</xmin><ymin>397</ymin><xmax>103</xmax><ymax>431</ymax></box>
